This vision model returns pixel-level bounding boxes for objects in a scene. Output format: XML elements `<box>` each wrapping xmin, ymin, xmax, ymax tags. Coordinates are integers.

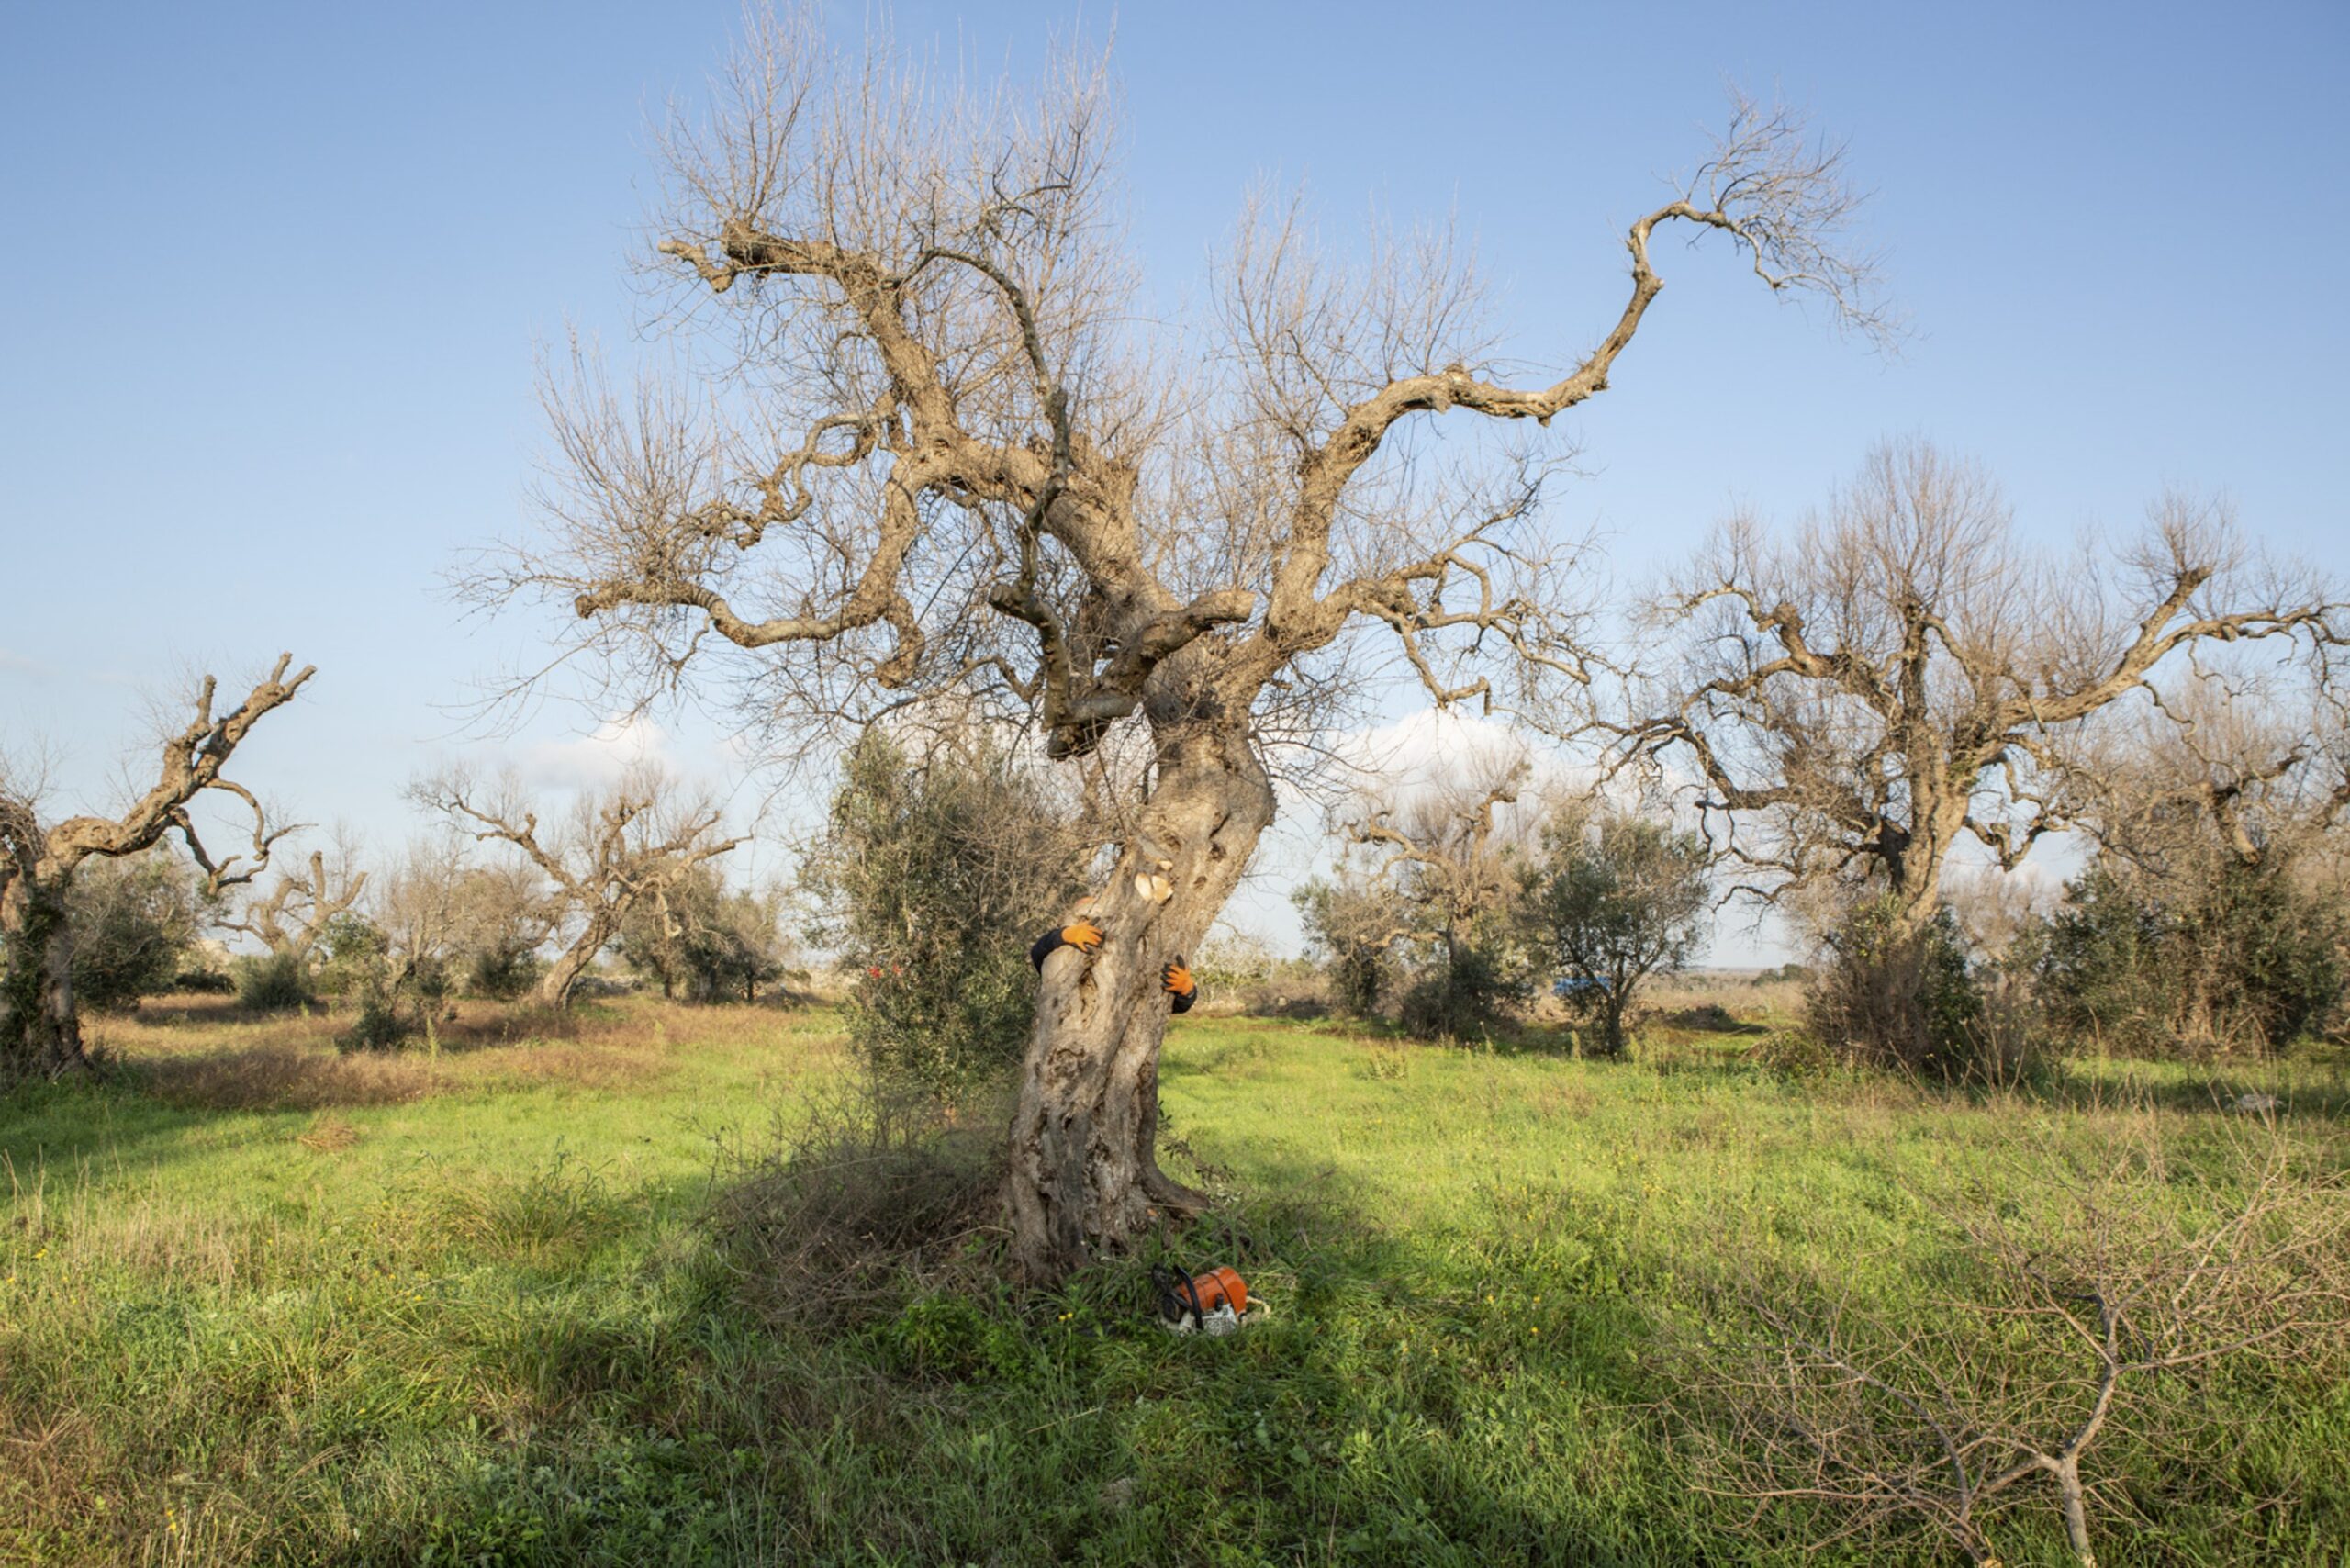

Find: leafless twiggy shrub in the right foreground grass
<box><xmin>1669</xmin><ymin>1116</ymin><xmax>2350</xmax><ymax>1563</ymax></box>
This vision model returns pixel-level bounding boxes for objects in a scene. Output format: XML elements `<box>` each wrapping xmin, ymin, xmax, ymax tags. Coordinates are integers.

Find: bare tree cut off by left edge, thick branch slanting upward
<box><xmin>0</xmin><ymin>654</ymin><xmax>312</xmax><ymax>1083</ymax></box>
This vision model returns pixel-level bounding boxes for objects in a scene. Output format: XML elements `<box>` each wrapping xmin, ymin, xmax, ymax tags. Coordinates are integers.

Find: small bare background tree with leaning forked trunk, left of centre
<box><xmin>411</xmin><ymin>767</ymin><xmax>745</xmax><ymax>1006</ymax></box>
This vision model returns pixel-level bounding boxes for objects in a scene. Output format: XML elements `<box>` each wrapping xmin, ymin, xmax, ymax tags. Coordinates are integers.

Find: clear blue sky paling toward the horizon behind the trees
<box><xmin>0</xmin><ymin>3</ymin><xmax>2350</xmax><ymax>957</ymax></box>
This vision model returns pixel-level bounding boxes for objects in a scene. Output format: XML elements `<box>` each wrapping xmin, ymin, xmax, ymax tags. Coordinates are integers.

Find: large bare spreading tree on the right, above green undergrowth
<box><xmin>1612</xmin><ymin>444</ymin><xmax>2350</xmax><ymax>934</ymax></box>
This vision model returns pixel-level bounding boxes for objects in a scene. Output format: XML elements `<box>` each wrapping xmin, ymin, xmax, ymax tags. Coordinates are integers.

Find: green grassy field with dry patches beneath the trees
<box><xmin>0</xmin><ymin>997</ymin><xmax>2350</xmax><ymax>1565</ymax></box>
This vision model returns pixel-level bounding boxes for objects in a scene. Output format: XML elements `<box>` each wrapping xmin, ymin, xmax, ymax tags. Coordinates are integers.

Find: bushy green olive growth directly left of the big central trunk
<box><xmin>801</xmin><ymin>729</ymin><xmax>1086</xmax><ymax>1103</ymax></box>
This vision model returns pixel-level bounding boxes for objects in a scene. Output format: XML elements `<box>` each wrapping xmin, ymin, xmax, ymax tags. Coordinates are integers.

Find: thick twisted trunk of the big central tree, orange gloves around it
<box><xmin>1006</xmin><ymin>734</ymin><xmax>1274</xmax><ymax>1282</ymax></box>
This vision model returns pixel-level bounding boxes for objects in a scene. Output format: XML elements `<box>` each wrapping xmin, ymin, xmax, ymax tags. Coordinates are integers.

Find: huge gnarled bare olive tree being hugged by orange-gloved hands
<box><xmin>475</xmin><ymin>12</ymin><xmax>1877</xmax><ymax>1276</ymax></box>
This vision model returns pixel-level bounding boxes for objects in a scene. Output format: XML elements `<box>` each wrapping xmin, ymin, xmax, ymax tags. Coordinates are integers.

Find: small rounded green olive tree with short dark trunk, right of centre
<box><xmin>1525</xmin><ymin>804</ymin><xmax>1713</xmax><ymax>1056</ymax></box>
